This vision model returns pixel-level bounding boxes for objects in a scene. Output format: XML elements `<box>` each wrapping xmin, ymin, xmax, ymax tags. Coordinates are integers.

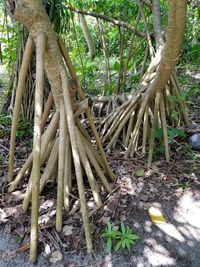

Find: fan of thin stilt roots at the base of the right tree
<box><xmin>94</xmin><ymin>66</ymin><xmax>188</xmax><ymax>166</ymax></box>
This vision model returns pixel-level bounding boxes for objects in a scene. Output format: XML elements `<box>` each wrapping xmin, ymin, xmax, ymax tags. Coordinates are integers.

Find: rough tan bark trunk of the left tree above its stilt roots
<box><xmin>11</xmin><ymin>0</ymin><xmax>63</xmax><ymax>108</ymax></box>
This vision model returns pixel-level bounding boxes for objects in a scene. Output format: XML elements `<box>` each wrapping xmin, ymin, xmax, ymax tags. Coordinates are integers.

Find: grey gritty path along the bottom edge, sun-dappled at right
<box><xmin>0</xmin><ymin>190</ymin><xmax>200</xmax><ymax>267</ymax></box>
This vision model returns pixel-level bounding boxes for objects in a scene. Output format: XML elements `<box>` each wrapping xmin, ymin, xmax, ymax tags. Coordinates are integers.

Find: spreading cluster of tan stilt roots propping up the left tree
<box><xmin>8</xmin><ymin>33</ymin><xmax>115</xmax><ymax>261</ymax></box>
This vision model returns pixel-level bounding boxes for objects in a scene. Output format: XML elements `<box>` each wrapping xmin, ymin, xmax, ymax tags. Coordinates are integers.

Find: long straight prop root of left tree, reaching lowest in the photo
<box><xmin>30</xmin><ymin>33</ymin><xmax>46</xmax><ymax>262</ymax></box>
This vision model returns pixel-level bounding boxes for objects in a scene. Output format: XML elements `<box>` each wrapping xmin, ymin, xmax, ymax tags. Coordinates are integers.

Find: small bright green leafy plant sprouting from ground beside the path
<box><xmin>102</xmin><ymin>223</ymin><xmax>139</xmax><ymax>251</ymax></box>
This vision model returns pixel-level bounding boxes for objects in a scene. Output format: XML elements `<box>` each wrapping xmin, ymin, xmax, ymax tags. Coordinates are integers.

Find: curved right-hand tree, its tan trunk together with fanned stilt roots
<box><xmin>102</xmin><ymin>0</ymin><xmax>188</xmax><ymax>165</ymax></box>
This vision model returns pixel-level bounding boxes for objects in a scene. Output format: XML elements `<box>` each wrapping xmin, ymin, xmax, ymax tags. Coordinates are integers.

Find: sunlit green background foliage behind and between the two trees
<box><xmin>0</xmin><ymin>0</ymin><xmax>200</xmax><ymax>99</ymax></box>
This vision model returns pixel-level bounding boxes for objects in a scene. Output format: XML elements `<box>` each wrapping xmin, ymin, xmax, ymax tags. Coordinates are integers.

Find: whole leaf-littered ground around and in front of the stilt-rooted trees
<box><xmin>0</xmin><ymin>66</ymin><xmax>200</xmax><ymax>267</ymax></box>
